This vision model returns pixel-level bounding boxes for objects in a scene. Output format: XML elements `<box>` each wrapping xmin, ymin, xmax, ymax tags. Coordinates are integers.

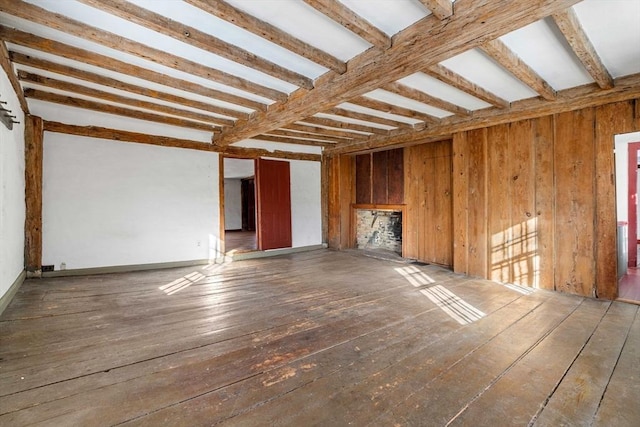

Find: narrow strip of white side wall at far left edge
<box><xmin>0</xmin><ymin>70</ymin><xmax>25</xmax><ymax>297</ymax></box>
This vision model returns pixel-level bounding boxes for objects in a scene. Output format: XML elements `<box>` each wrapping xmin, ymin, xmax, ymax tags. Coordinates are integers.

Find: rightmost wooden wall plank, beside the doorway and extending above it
<box><xmin>595</xmin><ymin>101</ymin><xmax>634</xmax><ymax>299</ymax></box>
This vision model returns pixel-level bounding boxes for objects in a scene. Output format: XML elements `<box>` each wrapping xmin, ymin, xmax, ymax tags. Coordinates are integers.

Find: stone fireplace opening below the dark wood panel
<box><xmin>356</xmin><ymin>209</ymin><xmax>402</xmax><ymax>256</ymax></box>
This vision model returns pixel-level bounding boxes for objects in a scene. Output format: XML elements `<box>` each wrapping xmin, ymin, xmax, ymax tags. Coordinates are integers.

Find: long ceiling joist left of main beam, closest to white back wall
<box><xmin>24</xmin><ymin>88</ymin><xmax>220</xmax><ymax>133</ymax></box>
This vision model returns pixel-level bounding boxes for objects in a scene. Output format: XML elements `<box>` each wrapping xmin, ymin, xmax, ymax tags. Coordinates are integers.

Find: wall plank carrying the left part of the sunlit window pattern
<box><xmin>487</xmin><ymin>125</ymin><xmax>511</xmax><ymax>282</ymax></box>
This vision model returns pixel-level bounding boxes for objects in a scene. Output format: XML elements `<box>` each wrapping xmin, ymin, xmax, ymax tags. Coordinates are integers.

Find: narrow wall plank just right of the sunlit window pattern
<box><xmin>533</xmin><ymin>116</ymin><xmax>555</xmax><ymax>290</ymax></box>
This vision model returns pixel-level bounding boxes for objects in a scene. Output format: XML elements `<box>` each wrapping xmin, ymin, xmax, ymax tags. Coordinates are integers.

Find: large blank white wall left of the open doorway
<box><xmin>42</xmin><ymin>132</ymin><xmax>219</xmax><ymax>270</ymax></box>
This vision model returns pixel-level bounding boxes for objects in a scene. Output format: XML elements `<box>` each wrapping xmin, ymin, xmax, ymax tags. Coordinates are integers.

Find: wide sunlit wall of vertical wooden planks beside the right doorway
<box><xmin>453</xmin><ymin>100</ymin><xmax>640</xmax><ymax>299</ymax></box>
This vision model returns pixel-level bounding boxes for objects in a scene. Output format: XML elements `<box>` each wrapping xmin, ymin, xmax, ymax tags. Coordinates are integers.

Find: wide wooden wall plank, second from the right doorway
<box><xmin>555</xmin><ymin>108</ymin><xmax>595</xmax><ymax>295</ymax></box>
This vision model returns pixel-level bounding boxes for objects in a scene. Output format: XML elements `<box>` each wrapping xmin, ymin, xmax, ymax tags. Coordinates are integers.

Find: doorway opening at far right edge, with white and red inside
<box><xmin>615</xmin><ymin>132</ymin><xmax>640</xmax><ymax>304</ymax></box>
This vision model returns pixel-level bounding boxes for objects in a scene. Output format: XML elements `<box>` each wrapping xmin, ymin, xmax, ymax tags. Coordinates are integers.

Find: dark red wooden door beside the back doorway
<box><xmin>255</xmin><ymin>159</ymin><xmax>291</xmax><ymax>251</ymax></box>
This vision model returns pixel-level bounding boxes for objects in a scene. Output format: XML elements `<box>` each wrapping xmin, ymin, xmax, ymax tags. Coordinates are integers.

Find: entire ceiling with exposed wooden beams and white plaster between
<box><xmin>0</xmin><ymin>0</ymin><xmax>640</xmax><ymax>154</ymax></box>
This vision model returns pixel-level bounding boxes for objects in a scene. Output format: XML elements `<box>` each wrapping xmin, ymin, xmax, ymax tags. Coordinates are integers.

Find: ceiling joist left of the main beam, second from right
<box><xmin>185</xmin><ymin>0</ymin><xmax>347</xmax><ymax>74</ymax></box>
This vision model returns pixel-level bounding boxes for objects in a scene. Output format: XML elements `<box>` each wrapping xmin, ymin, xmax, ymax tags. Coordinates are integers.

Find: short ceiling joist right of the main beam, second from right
<box><xmin>481</xmin><ymin>39</ymin><xmax>556</xmax><ymax>101</ymax></box>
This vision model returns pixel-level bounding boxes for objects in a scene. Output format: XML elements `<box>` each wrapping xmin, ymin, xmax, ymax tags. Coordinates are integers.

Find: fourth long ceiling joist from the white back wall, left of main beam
<box><xmin>0</xmin><ymin>25</ymin><xmax>267</xmax><ymax>111</ymax></box>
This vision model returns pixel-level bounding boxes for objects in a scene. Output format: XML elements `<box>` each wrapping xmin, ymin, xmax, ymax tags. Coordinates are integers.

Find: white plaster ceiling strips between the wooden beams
<box><xmin>0</xmin><ymin>0</ymin><xmax>640</xmax><ymax>152</ymax></box>
